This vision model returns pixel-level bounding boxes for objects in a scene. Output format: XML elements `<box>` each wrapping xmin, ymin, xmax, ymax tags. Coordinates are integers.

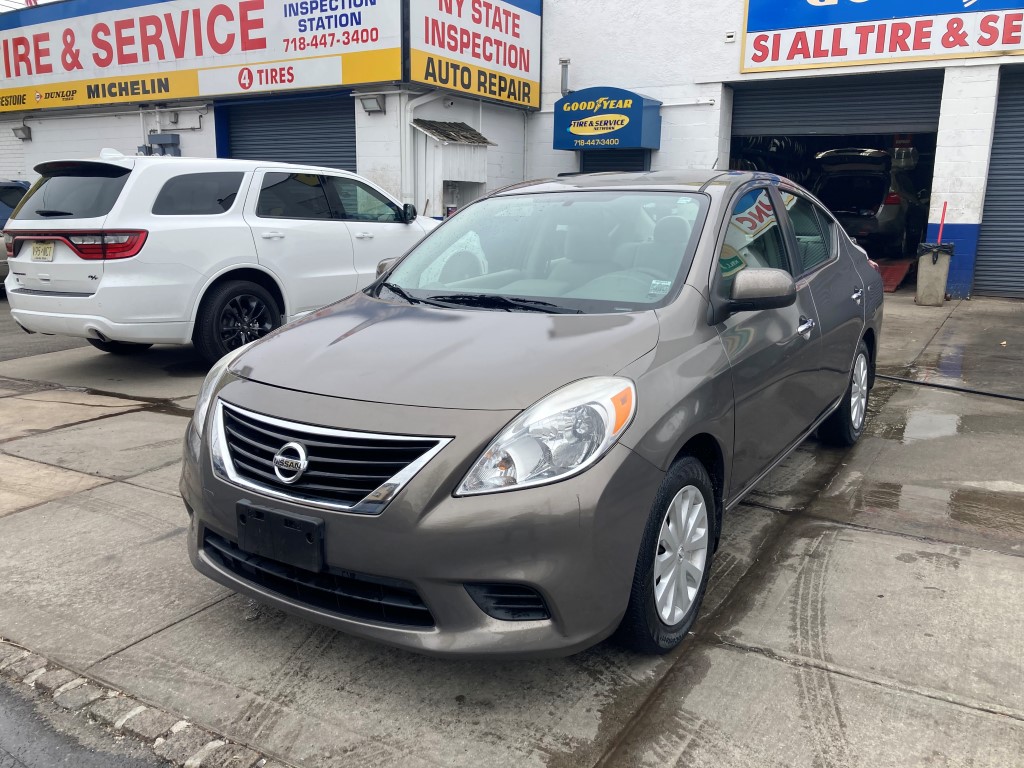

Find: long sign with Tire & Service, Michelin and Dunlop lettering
<box><xmin>0</xmin><ymin>0</ymin><xmax>401</xmax><ymax>113</ymax></box>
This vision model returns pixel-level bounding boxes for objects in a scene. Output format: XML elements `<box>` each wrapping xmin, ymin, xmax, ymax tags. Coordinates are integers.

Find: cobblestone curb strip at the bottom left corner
<box><xmin>0</xmin><ymin>639</ymin><xmax>289</xmax><ymax>768</ymax></box>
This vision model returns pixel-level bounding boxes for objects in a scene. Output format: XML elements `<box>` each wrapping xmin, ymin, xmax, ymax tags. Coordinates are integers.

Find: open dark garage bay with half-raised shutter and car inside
<box><xmin>730</xmin><ymin>71</ymin><xmax>943</xmax><ymax>275</ymax></box>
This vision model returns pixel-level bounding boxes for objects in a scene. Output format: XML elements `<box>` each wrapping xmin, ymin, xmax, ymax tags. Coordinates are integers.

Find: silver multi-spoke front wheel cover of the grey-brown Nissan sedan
<box><xmin>654</xmin><ymin>485</ymin><xmax>711</xmax><ymax>627</ymax></box>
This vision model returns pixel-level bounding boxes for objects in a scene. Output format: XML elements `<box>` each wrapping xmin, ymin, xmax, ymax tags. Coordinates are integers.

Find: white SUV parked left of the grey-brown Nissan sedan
<box><xmin>4</xmin><ymin>150</ymin><xmax>437</xmax><ymax>361</ymax></box>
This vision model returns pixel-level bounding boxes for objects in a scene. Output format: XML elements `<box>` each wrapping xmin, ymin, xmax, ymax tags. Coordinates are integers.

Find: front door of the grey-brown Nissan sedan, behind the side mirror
<box><xmin>712</xmin><ymin>185</ymin><xmax>824</xmax><ymax>495</ymax></box>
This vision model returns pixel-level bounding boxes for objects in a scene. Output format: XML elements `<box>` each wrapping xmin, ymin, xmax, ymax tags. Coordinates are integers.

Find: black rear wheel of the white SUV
<box><xmin>193</xmin><ymin>280</ymin><xmax>281</xmax><ymax>362</ymax></box>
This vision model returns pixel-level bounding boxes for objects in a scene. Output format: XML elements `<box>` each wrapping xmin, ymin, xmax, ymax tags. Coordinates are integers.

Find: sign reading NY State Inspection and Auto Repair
<box><xmin>407</xmin><ymin>0</ymin><xmax>541</xmax><ymax>110</ymax></box>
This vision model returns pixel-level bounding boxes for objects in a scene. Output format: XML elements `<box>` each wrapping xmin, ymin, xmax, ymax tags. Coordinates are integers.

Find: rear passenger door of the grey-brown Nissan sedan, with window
<box><xmin>786</xmin><ymin>193</ymin><xmax>865</xmax><ymax>404</ymax></box>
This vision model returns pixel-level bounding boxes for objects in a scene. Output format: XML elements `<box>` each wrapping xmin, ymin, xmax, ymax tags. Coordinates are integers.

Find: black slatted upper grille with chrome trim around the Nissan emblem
<box><xmin>221</xmin><ymin>403</ymin><xmax>447</xmax><ymax>512</ymax></box>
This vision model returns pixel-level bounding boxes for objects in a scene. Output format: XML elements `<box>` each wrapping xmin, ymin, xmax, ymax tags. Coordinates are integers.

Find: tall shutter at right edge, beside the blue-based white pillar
<box><xmin>974</xmin><ymin>69</ymin><xmax>1024</xmax><ymax>298</ymax></box>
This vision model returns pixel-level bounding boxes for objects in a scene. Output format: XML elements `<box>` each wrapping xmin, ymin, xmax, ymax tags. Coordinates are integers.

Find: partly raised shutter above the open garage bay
<box><xmin>732</xmin><ymin>70</ymin><xmax>944</xmax><ymax>136</ymax></box>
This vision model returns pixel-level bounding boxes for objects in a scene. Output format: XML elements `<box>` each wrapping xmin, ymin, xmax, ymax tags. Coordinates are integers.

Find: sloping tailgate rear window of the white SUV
<box><xmin>10</xmin><ymin>163</ymin><xmax>131</xmax><ymax>221</ymax></box>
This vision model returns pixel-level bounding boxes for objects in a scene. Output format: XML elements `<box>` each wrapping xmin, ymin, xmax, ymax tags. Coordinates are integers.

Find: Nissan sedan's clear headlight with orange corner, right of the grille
<box><xmin>456</xmin><ymin>377</ymin><xmax>636</xmax><ymax>496</ymax></box>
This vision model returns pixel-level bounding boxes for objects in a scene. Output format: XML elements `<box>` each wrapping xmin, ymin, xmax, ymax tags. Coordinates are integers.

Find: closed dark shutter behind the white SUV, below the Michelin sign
<box><xmin>218</xmin><ymin>91</ymin><xmax>355</xmax><ymax>171</ymax></box>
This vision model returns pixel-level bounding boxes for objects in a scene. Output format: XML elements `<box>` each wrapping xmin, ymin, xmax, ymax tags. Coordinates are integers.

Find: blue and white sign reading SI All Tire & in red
<box><xmin>742</xmin><ymin>0</ymin><xmax>1024</xmax><ymax>72</ymax></box>
